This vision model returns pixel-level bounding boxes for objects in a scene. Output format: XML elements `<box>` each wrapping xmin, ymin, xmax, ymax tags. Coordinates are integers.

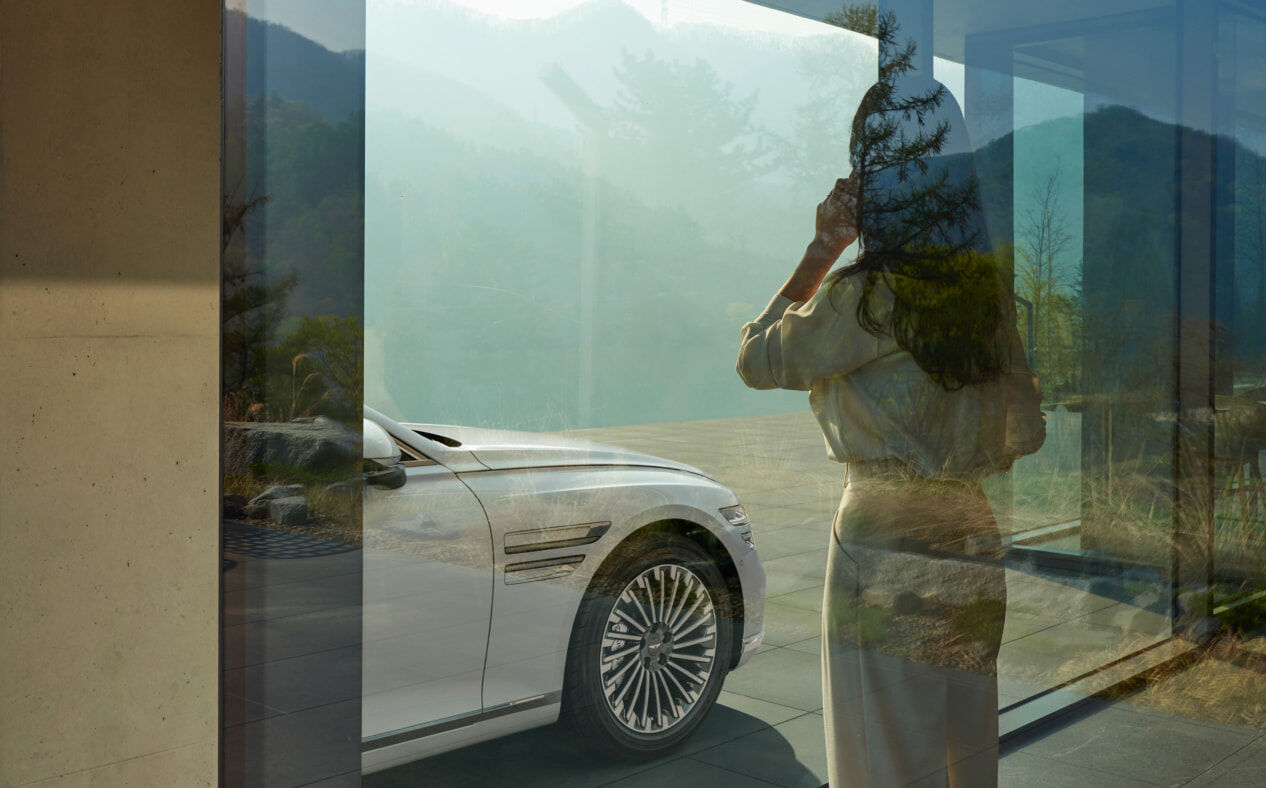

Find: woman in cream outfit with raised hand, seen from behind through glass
<box><xmin>738</xmin><ymin>3</ymin><xmax>1044</xmax><ymax>788</ymax></box>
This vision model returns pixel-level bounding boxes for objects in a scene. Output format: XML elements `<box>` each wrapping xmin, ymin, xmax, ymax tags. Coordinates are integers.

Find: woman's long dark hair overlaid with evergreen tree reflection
<box><xmin>832</xmin><ymin>16</ymin><xmax>1009</xmax><ymax>390</ymax></box>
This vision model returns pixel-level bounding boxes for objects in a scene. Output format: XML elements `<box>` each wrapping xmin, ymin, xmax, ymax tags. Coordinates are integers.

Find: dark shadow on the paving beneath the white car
<box><xmin>361</xmin><ymin>704</ymin><xmax>823</xmax><ymax>788</ymax></box>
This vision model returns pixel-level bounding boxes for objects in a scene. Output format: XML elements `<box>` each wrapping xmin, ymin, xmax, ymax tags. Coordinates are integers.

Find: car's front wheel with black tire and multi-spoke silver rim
<box><xmin>562</xmin><ymin>533</ymin><xmax>734</xmax><ymax>759</ymax></box>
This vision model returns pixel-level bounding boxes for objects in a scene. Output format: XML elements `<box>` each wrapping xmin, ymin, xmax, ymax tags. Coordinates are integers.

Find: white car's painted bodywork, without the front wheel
<box><xmin>362</xmin><ymin>408</ymin><xmax>765</xmax><ymax>773</ymax></box>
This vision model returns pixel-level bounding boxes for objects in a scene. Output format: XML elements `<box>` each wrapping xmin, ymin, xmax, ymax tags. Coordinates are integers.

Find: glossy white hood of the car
<box><xmin>404</xmin><ymin>423</ymin><xmax>711</xmax><ymax>479</ymax></box>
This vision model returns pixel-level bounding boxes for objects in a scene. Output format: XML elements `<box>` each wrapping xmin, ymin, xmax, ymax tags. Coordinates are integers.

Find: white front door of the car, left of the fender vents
<box><xmin>361</xmin><ymin>465</ymin><xmax>492</xmax><ymax>739</ymax></box>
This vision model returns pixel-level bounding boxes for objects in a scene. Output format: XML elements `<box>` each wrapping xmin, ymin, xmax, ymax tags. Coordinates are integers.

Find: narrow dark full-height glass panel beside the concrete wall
<box><xmin>220</xmin><ymin>0</ymin><xmax>365</xmax><ymax>785</ymax></box>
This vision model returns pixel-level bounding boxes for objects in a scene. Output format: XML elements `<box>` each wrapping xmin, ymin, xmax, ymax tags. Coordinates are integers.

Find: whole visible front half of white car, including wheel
<box><xmin>361</xmin><ymin>408</ymin><xmax>765</xmax><ymax>773</ymax></box>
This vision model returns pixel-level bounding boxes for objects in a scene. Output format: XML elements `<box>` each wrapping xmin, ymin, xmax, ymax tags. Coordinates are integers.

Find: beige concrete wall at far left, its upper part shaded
<box><xmin>0</xmin><ymin>0</ymin><xmax>220</xmax><ymax>787</ymax></box>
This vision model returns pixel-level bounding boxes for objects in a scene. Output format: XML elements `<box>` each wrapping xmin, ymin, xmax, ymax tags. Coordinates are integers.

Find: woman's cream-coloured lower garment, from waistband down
<box><xmin>823</xmin><ymin>479</ymin><xmax>1006</xmax><ymax>788</ymax></box>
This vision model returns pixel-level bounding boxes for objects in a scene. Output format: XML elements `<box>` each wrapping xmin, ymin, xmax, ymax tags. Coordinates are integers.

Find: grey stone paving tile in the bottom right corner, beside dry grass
<box><xmin>1020</xmin><ymin>707</ymin><xmax>1258</xmax><ymax>785</ymax></box>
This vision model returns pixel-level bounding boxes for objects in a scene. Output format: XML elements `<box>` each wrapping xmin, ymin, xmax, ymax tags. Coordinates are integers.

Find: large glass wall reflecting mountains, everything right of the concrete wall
<box><xmin>223</xmin><ymin>0</ymin><xmax>1266</xmax><ymax>785</ymax></box>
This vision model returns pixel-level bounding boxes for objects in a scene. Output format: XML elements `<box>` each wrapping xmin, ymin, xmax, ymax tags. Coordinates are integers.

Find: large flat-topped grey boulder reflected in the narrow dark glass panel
<box><xmin>224</xmin><ymin>416</ymin><xmax>361</xmax><ymax>475</ymax></box>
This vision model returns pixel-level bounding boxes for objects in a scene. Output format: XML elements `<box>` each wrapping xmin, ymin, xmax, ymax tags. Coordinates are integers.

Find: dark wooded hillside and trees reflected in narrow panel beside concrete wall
<box><xmin>222</xmin><ymin>95</ymin><xmax>363</xmax><ymax>421</ymax></box>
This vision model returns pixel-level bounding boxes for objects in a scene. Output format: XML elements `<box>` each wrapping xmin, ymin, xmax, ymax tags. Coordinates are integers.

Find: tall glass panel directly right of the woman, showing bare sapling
<box><xmin>999</xmin><ymin>13</ymin><xmax>1177</xmax><ymax>701</ymax></box>
